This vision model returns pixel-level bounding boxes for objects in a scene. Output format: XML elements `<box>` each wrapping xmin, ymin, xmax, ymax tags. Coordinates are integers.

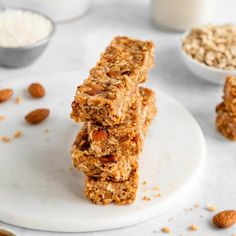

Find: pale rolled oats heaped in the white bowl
<box><xmin>182</xmin><ymin>24</ymin><xmax>236</xmax><ymax>70</ymax></box>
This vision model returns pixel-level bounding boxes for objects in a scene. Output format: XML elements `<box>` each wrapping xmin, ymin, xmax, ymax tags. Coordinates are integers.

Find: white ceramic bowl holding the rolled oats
<box><xmin>180</xmin><ymin>31</ymin><xmax>236</xmax><ymax>85</ymax></box>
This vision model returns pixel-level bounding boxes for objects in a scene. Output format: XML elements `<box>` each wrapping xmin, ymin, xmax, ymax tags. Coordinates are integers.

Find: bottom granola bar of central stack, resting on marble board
<box><xmin>85</xmin><ymin>168</ymin><xmax>138</xmax><ymax>205</ymax></box>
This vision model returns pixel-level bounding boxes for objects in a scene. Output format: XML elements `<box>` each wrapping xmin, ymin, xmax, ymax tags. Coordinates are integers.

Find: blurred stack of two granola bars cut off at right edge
<box><xmin>216</xmin><ymin>76</ymin><xmax>236</xmax><ymax>141</ymax></box>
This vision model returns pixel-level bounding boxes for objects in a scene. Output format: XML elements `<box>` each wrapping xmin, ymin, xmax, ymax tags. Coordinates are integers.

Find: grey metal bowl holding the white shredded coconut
<box><xmin>0</xmin><ymin>8</ymin><xmax>55</xmax><ymax>68</ymax></box>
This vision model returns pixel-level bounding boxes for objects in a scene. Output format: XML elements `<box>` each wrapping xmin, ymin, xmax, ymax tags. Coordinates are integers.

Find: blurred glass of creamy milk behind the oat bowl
<box><xmin>151</xmin><ymin>0</ymin><xmax>214</xmax><ymax>31</ymax></box>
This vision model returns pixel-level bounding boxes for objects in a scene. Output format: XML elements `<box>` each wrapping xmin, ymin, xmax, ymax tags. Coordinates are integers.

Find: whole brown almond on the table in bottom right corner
<box><xmin>213</xmin><ymin>210</ymin><xmax>236</xmax><ymax>228</ymax></box>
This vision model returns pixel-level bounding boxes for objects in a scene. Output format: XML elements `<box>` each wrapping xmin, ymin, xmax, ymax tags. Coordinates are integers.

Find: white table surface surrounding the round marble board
<box><xmin>0</xmin><ymin>0</ymin><xmax>236</xmax><ymax>236</ymax></box>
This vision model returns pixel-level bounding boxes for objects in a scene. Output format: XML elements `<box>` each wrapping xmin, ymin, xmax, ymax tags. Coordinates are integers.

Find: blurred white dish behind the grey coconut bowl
<box><xmin>1</xmin><ymin>0</ymin><xmax>90</xmax><ymax>22</ymax></box>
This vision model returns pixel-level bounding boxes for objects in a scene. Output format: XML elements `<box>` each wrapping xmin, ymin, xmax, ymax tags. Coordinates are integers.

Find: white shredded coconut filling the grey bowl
<box><xmin>0</xmin><ymin>9</ymin><xmax>53</xmax><ymax>48</ymax></box>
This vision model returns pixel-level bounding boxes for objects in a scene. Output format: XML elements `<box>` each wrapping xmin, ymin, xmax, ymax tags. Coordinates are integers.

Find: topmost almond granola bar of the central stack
<box><xmin>71</xmin><ymin>36</ymin><xmax>154</xmax><ymax>126</ymax></box>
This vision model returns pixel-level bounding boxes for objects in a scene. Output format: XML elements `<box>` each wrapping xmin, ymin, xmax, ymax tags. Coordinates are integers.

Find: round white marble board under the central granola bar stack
<box><xmin>0</xmin><ymin>71</ymin><xmax>205</xmax><ymax>232</ymax></box>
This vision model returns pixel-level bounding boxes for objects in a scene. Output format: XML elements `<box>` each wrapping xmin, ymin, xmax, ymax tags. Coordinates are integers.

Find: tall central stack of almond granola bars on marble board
<box><xmin>72</xmin><ymin>37</ymin><xmax>156</xmax><ymax>204</ymax></box>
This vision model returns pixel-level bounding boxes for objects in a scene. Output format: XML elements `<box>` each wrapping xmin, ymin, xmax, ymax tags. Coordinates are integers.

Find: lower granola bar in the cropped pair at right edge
<box><xmin>216</xmin><ymin>102</ymin><xmax>236</xmax><ymax>141</ymax></box>
